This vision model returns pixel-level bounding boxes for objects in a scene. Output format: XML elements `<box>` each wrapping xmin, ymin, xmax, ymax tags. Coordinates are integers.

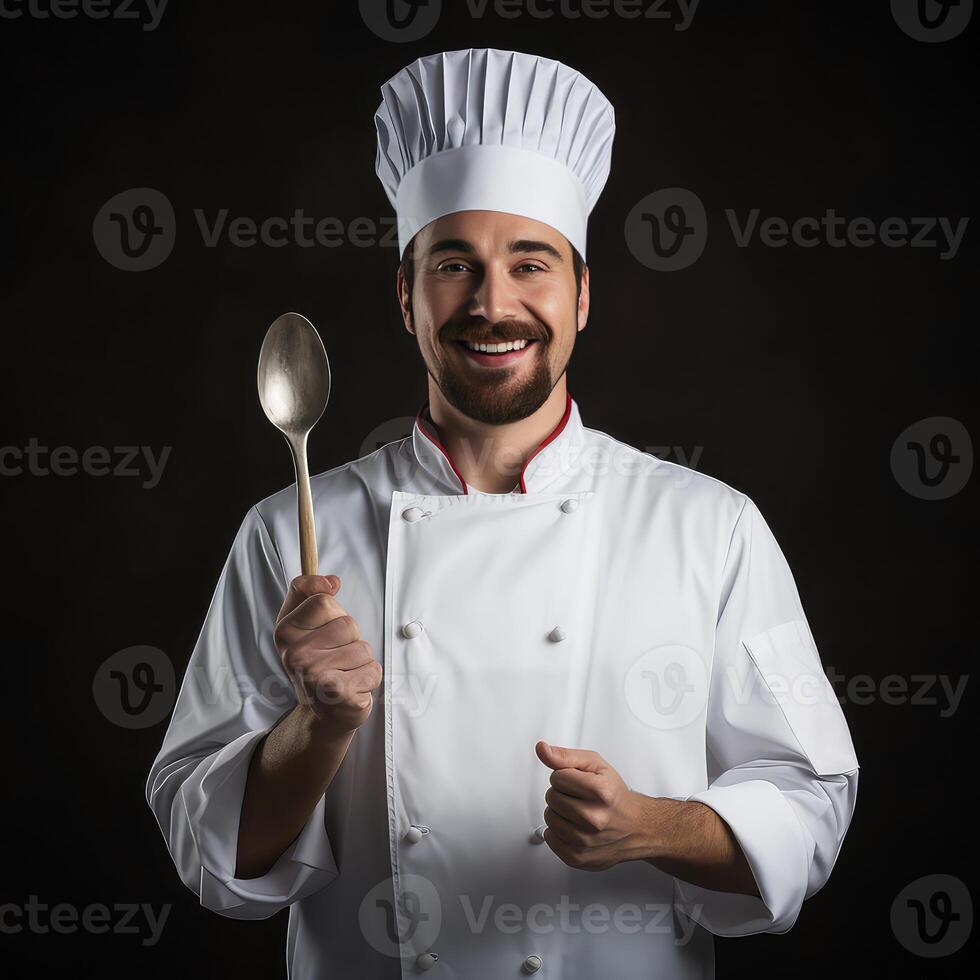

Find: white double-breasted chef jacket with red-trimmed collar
<box><xmin>146</xmin><ymin>396</ymin><xmax>858</xmax><ymax>980</ymax></box>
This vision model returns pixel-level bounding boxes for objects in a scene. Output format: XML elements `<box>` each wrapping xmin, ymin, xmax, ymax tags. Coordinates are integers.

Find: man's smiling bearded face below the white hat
<box><xmin>398</xmin><ymin>211</ymin><xmax>589</xmax><ymax>425</ymax></box>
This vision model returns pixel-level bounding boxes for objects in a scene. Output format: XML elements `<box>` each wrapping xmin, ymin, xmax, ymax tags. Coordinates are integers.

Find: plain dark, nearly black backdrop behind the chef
<box><xmin>0</xmin><ymin>0</ymin><xmax>980</xmax><ymax>977</ymax></box>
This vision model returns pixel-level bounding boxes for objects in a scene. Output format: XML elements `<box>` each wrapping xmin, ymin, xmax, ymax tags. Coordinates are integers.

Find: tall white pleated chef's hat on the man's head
<box><xmin>374</xmin><ymin>48</ymin><xmax>616</xmax><ymax>258</ymax></box>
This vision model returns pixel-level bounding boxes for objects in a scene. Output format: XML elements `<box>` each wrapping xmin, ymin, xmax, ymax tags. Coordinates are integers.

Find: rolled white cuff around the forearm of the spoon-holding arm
<box><xmin>183</xmin><ymin>731</ymin><xmax>338</xmax><ymax>919</ymax></box>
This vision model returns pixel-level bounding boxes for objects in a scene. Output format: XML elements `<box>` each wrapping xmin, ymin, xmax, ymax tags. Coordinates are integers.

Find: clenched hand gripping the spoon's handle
<box><xmin>275</xmin><ymin>575</ymin><xmax>382</xmax><ymax>738</ymax></box>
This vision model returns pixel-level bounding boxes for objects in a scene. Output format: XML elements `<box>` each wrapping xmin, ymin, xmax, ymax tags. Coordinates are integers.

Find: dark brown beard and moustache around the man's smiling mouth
<box><xmin>435</xmin><ymin>321</ymin><xmax>567</xmax><ymax>425</ymax></box>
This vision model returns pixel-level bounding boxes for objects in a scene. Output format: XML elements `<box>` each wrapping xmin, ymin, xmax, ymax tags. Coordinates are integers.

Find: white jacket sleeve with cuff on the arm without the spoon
<box><xmin>675</xmin><ymin>498</ymin><xmax>858</xmax><ymax>936</ymax></box>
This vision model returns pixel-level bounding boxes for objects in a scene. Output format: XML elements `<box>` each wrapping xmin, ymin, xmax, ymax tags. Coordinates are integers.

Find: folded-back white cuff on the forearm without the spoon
<box><xmin>674</xmin><ymin>779</ymin><xmax>809</xmax><ymax>936</ymax></box>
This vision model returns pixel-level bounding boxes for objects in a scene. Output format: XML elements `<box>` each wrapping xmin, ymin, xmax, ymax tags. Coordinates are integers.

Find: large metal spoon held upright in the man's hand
<box><xmin>258</xmin><ymin>313</ymin><xmax>330</xmax><ymax>575</ymax></box>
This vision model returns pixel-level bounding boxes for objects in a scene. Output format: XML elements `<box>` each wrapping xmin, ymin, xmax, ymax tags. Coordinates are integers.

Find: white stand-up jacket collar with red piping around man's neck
<box><xmin>412</xmin><ymin>395</ymin><xmax>585</xmax><ymax>494</ymax></box>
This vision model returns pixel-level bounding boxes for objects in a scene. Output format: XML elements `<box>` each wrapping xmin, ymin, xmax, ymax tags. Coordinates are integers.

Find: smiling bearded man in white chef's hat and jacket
<box><xmin>147</xmin><ymin>50</ymin><xmax>858</xmax><ymax>980</ymax></box>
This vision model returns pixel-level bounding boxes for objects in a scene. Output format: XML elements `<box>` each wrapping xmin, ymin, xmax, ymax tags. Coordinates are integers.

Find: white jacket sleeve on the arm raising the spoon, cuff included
<box><xmin>146</xmin><ymin>508</ymin><xmax>337</xmax><ymax>919</ymax></box>
